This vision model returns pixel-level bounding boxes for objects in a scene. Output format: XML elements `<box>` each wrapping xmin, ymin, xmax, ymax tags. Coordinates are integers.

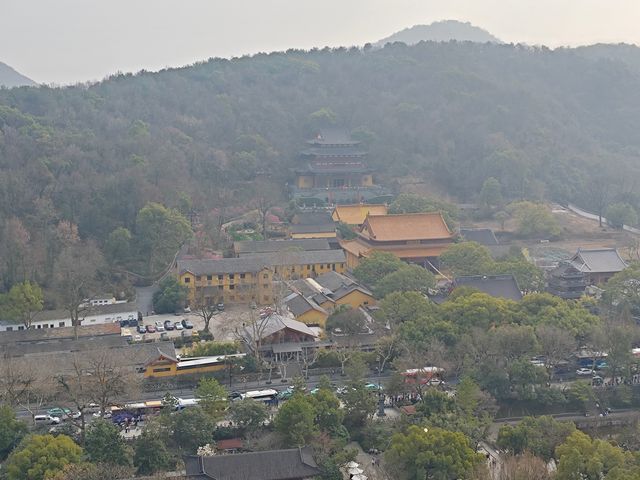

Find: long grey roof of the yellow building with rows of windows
<box><xmin>178</xmin><ymin>250</ymin><xmax>346</xmax><ymax>275</ymax></box>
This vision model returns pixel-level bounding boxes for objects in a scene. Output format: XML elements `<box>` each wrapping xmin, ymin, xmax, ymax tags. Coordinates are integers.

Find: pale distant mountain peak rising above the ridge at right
<box><xmin>375</xmin><ymin>20</ymin><xmax>503</xmax><ymax>47</ymax></box>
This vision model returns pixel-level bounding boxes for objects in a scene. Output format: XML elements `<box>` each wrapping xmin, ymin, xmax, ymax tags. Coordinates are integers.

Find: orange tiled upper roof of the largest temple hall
<box><xmin>361</xmin><ymin>213</ymin><xmax>452</xmax><ymax>242</ymax></box>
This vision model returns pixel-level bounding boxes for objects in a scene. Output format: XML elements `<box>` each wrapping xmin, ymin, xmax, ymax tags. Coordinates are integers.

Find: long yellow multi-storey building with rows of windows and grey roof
<box><xmin>177</xmin><ymin>250</ymin><xmax>346</xmax><ymax>305</ymax></box>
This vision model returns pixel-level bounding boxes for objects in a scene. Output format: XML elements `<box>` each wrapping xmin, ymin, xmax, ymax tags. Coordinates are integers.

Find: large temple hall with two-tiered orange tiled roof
<box><xmin>340</xmin><ymin>213</ymin><xmax>454</xmax><ymax>268</ymax></box>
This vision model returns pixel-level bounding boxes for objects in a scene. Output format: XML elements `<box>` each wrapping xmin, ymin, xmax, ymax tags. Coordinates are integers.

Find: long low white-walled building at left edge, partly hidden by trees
<box><xmin>0</xmin><ymin>302</ymin><xmax>138</xmax><ymax>332</ymax></box>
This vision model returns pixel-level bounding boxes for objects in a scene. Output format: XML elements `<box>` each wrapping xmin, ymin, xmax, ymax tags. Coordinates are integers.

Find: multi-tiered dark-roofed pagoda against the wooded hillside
<box><xmin>292</xmin><ymin>130</ymin><xmax>386</xmax><ymax>204</ymax></box>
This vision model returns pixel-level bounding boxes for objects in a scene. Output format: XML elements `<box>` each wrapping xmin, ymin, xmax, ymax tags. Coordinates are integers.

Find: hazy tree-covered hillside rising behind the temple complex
<box><xmin>0</xmin><ymin>42</ymin><xmax>640</xmax><ymax>296</ymax></box>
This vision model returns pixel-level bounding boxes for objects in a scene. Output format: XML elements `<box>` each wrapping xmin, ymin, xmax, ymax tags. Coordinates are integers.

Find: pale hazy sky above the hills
<box><xmin>0</xmin><ymin>0</ymin><xmax>640</xmax><ymax>83</ymax></box>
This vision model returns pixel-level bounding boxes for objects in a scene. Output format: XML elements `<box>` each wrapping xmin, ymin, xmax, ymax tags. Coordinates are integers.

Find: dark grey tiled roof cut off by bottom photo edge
<box><xmin>184</xmin><ymin>448</ymin><xmax>320</xmax><ymax>480</ymax></box>
